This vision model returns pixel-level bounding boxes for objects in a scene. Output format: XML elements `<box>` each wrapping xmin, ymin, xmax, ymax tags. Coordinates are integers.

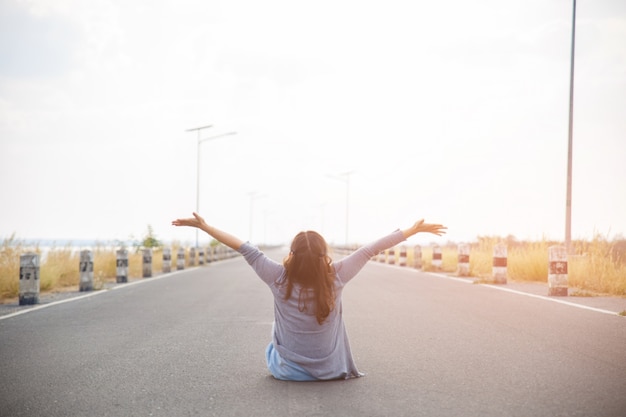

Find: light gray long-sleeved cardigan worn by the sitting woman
<box><xmin>239</xmin><ymin>230</ymin><xmax>404</xmax><ymax>379</ymax></box>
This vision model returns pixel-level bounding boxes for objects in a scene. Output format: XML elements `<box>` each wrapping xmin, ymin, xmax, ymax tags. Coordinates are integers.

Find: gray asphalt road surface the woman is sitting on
<box><xmin>0</xmin><ymin>252</ymin><xmax>626</xmax><ymax>417</ymax></box>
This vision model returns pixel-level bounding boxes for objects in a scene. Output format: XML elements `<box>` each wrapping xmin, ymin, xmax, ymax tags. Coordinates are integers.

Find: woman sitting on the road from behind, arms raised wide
<box><xmin>172</xmin><ymin>213</ymin><xmax>446</xmax><ymax>381</ymax></box>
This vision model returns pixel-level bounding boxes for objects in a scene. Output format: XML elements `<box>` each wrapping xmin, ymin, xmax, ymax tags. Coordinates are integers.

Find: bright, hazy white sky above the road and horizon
<box><xmin>0</xmin><ymin>0</ymin><xmax>626</xmax><ymax>244</ymax></box>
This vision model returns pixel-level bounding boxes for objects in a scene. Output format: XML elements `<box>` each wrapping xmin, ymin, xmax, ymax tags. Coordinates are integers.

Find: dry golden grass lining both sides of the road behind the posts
<box><xmin>0</xmin><ymin>231</ymin><xmax>626</xmax><ymax>303</ymax></box>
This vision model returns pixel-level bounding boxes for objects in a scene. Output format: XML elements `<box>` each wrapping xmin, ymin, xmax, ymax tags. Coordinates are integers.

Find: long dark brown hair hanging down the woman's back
<box><xmin>283</xmin><ymin>231</ymin><xmax>335</xmax><ymax>324</ymax></box>
